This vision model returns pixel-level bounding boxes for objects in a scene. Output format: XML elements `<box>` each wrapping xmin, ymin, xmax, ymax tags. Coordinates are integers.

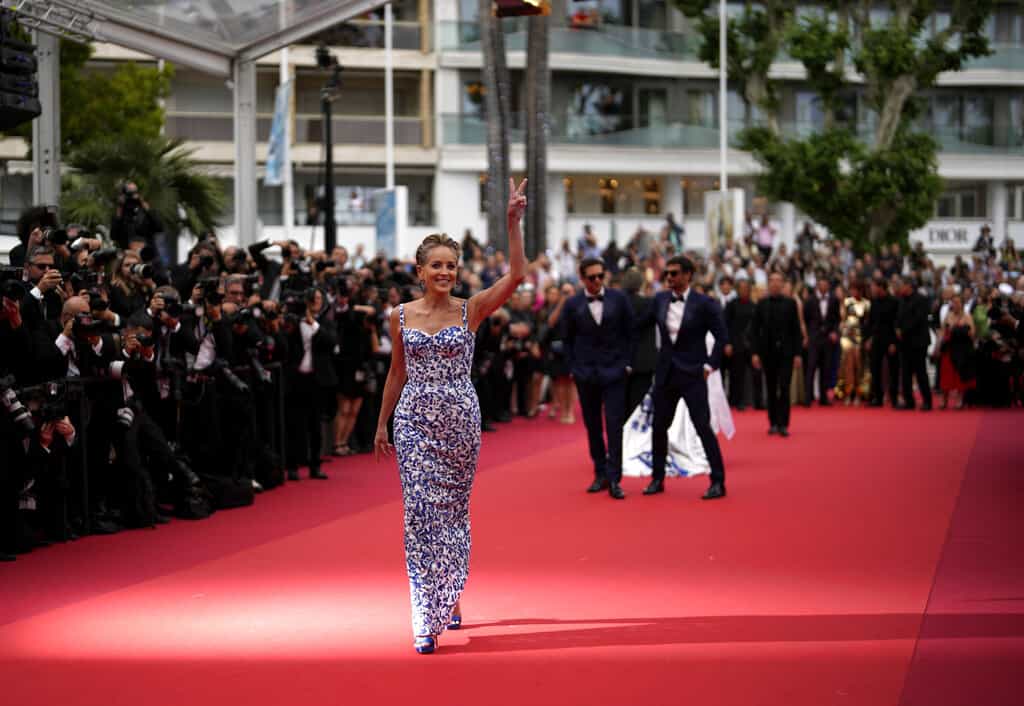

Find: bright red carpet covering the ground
<box><xmin>0</xmin><ymin>409</ymin><xmax>1024</xmax><ymax>706</ymax></box>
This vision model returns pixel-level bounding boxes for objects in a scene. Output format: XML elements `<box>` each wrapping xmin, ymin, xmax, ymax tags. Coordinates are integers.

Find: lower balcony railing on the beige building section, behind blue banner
<box><xmin>166</xmin><ymin>112</ymin><xmax>426</xmax><ymax>146</ymax></box>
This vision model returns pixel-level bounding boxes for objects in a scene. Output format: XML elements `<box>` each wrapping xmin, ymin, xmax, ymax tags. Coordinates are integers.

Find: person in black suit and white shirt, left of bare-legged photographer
<box><xmin>285</xmin><ymin>287</ymin><xmax>338</xmax><ymax>481</ymax></box>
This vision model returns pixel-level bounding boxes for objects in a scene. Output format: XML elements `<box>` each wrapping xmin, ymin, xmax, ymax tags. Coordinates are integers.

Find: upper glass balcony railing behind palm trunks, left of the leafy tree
<box><xmin>439</xmin><ymin>17</ymin><xmax>700</xmax><ymax>60</ymax></box>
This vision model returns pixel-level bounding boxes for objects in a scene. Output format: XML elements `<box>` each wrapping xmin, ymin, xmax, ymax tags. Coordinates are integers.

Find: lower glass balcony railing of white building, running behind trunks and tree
<box><xmin>441</xmin><ymin>114</ymin><xmax>1024</xmax><ymax>156</ymax></box>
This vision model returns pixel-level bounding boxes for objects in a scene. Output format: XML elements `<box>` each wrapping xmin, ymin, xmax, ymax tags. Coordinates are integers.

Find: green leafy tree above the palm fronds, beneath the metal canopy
<box><xmin>4</xmin><ymin>41</ymin><xmax>174</xmax><ymax>153</ymax></box>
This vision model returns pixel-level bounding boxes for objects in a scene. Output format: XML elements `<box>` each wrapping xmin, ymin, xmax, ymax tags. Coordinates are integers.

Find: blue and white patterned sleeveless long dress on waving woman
<box><xmin>394</xmin><ymin>301</ymin><xmax>480</xmax><ymax>635</ymax></box>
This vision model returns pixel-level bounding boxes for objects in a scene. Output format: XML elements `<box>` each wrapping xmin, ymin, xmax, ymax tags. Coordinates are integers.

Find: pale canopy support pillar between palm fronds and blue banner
<box><xmin>234</xmin><ymin>61</ymin><xmax>259</xmax><ymax>247</ymax></box>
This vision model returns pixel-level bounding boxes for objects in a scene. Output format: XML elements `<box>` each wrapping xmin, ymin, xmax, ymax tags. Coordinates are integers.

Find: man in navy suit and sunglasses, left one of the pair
<box><xmin>562</xmin><ymin>257</ymin><xmax>633</xmax><ymax>500</ymax></box>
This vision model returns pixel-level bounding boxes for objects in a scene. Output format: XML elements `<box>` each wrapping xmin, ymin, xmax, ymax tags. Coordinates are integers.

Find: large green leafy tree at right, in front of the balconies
<box><xmin>677</xmin><ymin>0</ymin><xmax>994</xmax><ymax>248</ymax></box>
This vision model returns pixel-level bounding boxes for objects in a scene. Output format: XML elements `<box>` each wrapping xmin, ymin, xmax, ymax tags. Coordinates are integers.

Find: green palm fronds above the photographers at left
<box><xmin>60</xmin><ymin>134</ymin><xmax>226</xmax><ymax>256</ymax></box>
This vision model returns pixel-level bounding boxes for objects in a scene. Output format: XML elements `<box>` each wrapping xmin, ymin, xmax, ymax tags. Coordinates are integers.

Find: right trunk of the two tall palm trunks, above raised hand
<box><xmin>526</xmin><ymin>15</ymin><xmax>551</xmax><ymax>259</ymax></box>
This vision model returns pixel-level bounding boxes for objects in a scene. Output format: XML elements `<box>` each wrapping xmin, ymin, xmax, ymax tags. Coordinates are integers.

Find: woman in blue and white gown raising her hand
<box><xmin>374</xmin><ymin>179</ymin><xmax>526</xmax><ymax>654</ymax></box>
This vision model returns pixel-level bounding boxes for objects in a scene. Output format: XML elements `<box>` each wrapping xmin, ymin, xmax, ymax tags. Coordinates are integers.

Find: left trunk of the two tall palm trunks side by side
<box><xmin>479</xmin><ymin>0</ymin><xmax>512</xmax><ymax>250</ymax></box>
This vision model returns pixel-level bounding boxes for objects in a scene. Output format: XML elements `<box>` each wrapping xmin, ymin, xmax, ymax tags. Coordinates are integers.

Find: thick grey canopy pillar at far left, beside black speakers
<box><xmin>32</xmin><ymin>32</ymin><xmax>60</xmax><ymax>205</ymax></box>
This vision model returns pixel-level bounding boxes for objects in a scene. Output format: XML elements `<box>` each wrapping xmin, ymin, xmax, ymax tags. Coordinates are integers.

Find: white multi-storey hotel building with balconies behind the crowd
<box><xmin>6</xmin><ymin>0</ymin><xmax>1024</xmax><ymax>259</ymax></box>
